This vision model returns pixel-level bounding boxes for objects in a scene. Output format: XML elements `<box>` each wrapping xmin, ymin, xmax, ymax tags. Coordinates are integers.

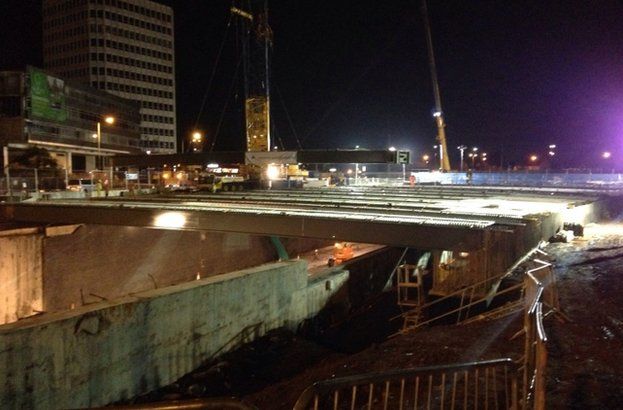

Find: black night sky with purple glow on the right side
<box><xmin>0</xmin><ymin>0</ymin><xmax>623</xmax><ymax>168</ymax></box>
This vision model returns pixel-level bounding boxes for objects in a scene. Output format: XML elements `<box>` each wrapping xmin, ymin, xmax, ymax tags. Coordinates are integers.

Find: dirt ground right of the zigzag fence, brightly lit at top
<box><xmin>546</xmin><ymin>224</ymin><xmax>623</xmax><ymax>409</ymax></box>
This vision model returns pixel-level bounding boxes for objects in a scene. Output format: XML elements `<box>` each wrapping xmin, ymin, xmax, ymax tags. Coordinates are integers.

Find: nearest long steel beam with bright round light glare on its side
<box><xmin>0</xmin><ymin>201</ymin><xmax>493</xmax><ymax>251</ymax></box>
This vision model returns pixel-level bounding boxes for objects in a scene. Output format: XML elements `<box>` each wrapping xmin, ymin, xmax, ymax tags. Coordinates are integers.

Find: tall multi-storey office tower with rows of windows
<box><xmin>43</xmin><ymin>0</ymin><xmax>177</xmax><ymax>153</ymax></box>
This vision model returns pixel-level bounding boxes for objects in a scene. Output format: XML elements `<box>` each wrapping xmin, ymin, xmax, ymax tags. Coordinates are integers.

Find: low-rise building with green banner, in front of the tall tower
<box><xmin>0</xmin><ymin>67</ymin><xmax>141</xmax><ymax>173</ymax></box>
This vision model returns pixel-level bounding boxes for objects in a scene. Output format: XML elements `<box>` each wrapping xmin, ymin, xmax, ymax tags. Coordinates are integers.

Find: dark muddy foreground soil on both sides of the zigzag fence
<box><xmin>137</xmin><ymin>225</ymin><xmax>623</xmax><ymax>409</ymax></box>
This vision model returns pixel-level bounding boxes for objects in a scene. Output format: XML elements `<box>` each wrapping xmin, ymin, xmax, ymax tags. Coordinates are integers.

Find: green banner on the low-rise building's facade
<box><xmin>28</xmin><ymin>67</ymin><xmax>67</xmax><ymax>122</ymax></box>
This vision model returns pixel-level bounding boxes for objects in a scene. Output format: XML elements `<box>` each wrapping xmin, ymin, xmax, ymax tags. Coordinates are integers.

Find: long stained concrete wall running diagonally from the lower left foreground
<box><xmin>0</xmin><ymin>261</ymin><xmax>348</xmax><ymax>409</ymax></box>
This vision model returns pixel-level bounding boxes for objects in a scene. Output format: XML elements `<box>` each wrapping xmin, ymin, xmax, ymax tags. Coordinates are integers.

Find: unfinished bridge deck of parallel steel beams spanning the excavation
<box><xmin>0</xmin><ymin>187</ymin><xmax>594</xmax><ymax>250</ymax></box>
